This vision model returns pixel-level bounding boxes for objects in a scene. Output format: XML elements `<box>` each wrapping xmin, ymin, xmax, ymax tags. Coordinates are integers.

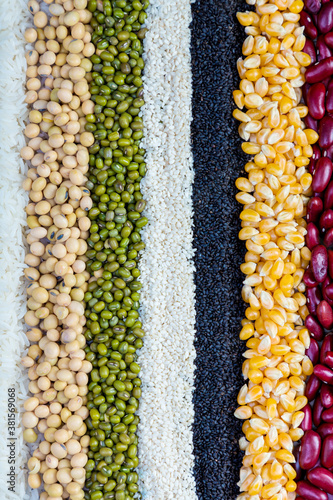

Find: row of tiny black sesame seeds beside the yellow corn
<box><xmin>191</xmin><ymin>0</ymin><xmax>246</xmax><ymax>500</ymax></box>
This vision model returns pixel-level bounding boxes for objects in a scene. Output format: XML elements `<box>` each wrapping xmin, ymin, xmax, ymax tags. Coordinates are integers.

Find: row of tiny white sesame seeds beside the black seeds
<box><xmin>139</xmin><ymin>0</ymin><xmax>196</xmax><ymax>500</ymax></box>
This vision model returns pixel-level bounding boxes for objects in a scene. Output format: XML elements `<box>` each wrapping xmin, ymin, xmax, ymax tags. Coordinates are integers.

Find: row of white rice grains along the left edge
<box><xmin>0</xmin><ymin>0</ymin><xmax>38</xmax><ymax>500</ymax></box>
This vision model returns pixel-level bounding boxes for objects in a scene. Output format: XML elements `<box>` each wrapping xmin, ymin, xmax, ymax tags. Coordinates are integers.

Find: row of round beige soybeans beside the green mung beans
<box><xmin>21</xmin><ymin>0</ymin><xmax>95</xmax><ymax>500</ymax></box>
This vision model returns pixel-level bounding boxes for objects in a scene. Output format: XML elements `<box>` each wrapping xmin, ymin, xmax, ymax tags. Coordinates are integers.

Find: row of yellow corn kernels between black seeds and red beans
<box><xmin>234</xmin><ymin>0</ymin><xmax>318</xmax><ymax>500</ymax></box>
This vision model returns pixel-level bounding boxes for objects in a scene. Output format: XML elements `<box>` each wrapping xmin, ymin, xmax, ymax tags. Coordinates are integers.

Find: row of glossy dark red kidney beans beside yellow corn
<box><xmin>295</xmin><ymin>0</ymin><xmax>333</xmax><ymax>500</ymax></box>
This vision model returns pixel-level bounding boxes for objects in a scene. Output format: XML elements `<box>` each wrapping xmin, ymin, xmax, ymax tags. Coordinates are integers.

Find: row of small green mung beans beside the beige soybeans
<box><xmin>83</xmin><ymin>0</ymin><xmax>149</xmax><ymax>500</ymax></box>
